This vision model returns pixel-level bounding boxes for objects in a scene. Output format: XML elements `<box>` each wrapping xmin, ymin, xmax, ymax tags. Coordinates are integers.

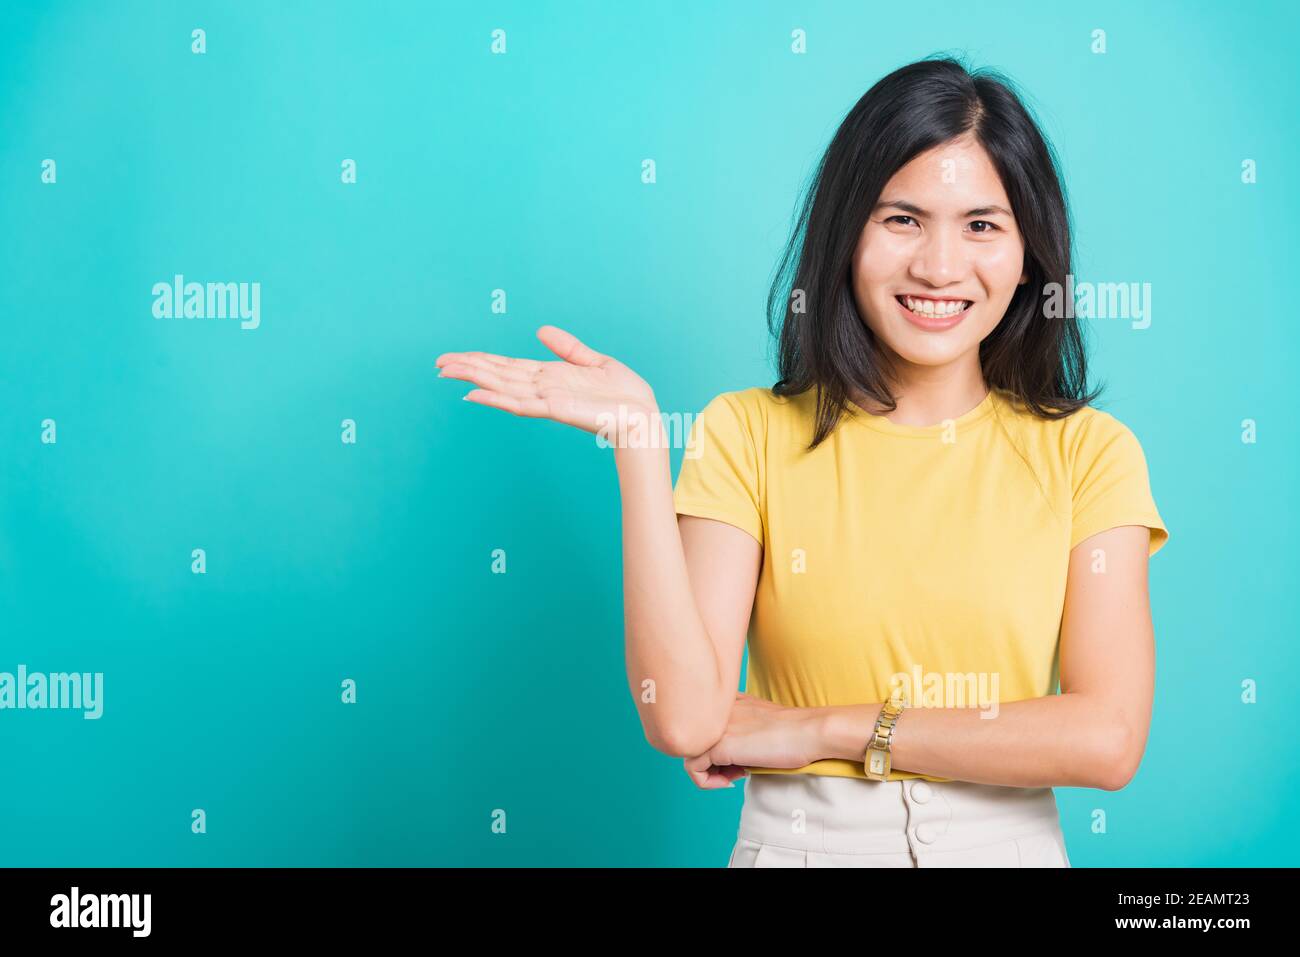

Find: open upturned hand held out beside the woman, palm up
<box><xmin>437</xmin><ymin>325</ymin><xmax>657</xmax><ymax>432</ymax></box>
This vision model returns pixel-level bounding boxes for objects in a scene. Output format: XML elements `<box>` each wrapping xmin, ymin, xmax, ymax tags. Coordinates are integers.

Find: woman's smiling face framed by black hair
<box><xmin>853</xmin><ymin>137</ymin><xmax>1028</xmax><ymax>381</ymax></box>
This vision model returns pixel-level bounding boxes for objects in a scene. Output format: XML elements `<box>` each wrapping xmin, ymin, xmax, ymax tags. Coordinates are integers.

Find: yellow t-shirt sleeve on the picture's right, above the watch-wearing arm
<box><xmin>1070</xmin><ymin>410</ymin><xmax>1169</xmax><ymax>557</ymax></box>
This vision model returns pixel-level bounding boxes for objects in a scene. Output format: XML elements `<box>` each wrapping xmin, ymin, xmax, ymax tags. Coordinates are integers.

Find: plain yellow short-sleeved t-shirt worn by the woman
<box><xmin>673</xmin><ymin>387</ymin><xmax>1169</xmax><ymax>781</ymax></box>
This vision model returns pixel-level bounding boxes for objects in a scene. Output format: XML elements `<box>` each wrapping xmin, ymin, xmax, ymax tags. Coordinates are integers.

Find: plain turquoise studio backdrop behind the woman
<box><xmin>0</xmin><ymin>0</ymin><xmax>1300</xmax><ymax>866</ymax></box>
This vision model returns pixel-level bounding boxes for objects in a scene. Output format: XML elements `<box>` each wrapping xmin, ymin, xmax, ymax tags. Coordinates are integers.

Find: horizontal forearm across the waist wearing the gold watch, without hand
<box><xmin>816</xmin><ymin>694</ymin><xmax>1141</xmax><ymax>791</ymax></box>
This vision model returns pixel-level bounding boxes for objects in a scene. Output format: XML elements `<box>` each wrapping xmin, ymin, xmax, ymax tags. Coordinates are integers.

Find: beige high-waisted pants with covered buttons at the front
<box><xmin>727</xmin><ymin>774</ymin><xmax>1070</xmax><ymax>867</ymax></box>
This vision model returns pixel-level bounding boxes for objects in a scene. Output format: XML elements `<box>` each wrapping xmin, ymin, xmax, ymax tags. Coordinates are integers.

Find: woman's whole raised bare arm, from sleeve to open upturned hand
<box><xmin>438</xmin><ymin>326</ymin><xmax>762</xmax><ymax>757</ymax></box>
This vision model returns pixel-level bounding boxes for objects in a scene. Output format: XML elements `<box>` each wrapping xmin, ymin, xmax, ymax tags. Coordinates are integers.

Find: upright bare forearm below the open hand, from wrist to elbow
<box><xmin>614</xmin><ymin>434</ymin><xmax>735</xmax><ymax>757</ymax></box>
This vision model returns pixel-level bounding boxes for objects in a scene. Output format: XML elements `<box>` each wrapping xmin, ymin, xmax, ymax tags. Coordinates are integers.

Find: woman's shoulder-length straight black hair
<box><xmin>767</xmin><ymin>56</ymin><xmax>1100</xmax><ymax>449</ymax></box>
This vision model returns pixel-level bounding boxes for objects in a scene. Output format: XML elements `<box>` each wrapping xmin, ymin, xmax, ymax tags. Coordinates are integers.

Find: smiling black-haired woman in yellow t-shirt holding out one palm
<box><xmin>438</xmin><ymin>59</ymin><xmax>1169</xmax><ymax>867</ymax></box>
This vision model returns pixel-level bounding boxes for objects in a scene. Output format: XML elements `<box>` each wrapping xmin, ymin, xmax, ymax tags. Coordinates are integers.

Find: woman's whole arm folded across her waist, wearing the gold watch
<box><xmin>686</xmin><ymin>525</ymin><xmax>1156</xmax><ymax>791</ymax></box>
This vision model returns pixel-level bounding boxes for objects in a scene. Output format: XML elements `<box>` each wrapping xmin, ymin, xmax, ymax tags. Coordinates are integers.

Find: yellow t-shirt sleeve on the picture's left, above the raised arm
<box><xmin>672</xmin><ymin>393</ymin><xmax>763</xmax><ymax>545</ymax></box>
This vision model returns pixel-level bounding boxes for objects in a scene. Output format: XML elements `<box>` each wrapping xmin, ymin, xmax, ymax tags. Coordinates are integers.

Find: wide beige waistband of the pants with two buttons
<box><xmin>737</xmin><ymin>774</ymin><xmax>1061</xmax><ymax>854</ymax></box>
